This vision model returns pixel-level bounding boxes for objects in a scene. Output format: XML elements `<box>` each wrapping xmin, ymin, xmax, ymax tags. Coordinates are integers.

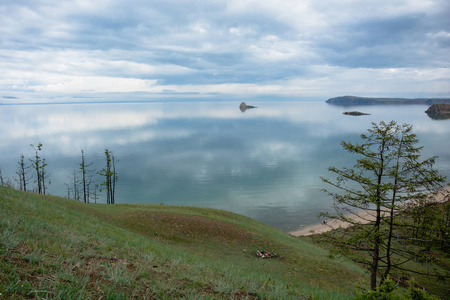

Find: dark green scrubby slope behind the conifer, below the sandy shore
<box><xmin>308</xmin><ymin>200</ymin><xmax>450</xmax><ymax>299</ymax></box>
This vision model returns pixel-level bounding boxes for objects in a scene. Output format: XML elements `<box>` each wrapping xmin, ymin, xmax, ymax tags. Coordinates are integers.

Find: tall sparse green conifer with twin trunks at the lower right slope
<box><xmin>321</xmin><ymin>121</ymin><xmax>445</xmax><ymax>290</ymax></box>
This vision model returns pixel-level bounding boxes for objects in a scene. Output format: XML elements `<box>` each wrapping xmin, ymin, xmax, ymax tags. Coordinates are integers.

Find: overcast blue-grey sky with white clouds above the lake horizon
<box><xmin>0</xmin><ymin>0</ymin><xmax>450</xmax><ymax>103</ymax></box>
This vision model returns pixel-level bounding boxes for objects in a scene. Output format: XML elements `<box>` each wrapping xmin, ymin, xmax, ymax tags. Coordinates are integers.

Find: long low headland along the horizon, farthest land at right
<box><xmin>326</xmin><ymin>96</ymin><xmax>450</xmax><ymax>106</ymax></box>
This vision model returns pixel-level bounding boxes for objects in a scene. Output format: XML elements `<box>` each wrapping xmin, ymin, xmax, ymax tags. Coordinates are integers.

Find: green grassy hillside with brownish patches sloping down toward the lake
<box><xmin>0</xmin><ymin>187</ymin><xmax>367</xmax><ymax>299</ymax></box>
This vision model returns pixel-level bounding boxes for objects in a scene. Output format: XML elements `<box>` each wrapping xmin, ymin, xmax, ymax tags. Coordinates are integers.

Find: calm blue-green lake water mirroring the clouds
<box><xmin>0</xmin><ymin>101</ymin><xmax>450</xmax><ymax>231</ymax></box>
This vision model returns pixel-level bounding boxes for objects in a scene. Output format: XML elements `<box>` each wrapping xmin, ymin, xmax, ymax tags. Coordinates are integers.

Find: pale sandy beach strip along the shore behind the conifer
<box><xmin>290</xmin><ymin>187</ymin><xmax>450</xmax><ymax>236</ymax></box>
